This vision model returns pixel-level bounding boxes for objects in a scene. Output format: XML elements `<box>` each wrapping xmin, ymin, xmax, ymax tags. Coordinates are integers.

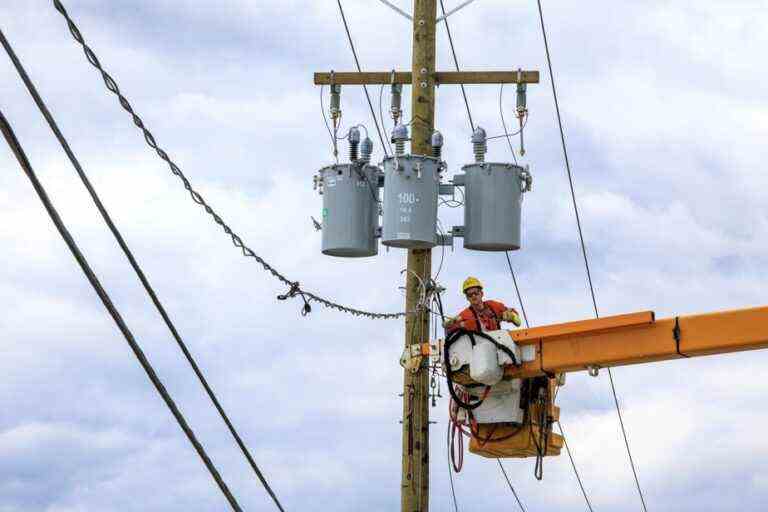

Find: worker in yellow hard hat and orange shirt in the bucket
<box><xmin>443</xmin><ymin>277</ymin><xmax>521</xmax><ymax>332</ymax></box>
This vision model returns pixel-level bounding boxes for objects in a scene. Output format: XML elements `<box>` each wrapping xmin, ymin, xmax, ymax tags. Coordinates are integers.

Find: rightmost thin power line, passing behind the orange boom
<box><xmin>536</xmin><ymin>0</ymin><xmax>648</xmax><ymax>512</ymax></box>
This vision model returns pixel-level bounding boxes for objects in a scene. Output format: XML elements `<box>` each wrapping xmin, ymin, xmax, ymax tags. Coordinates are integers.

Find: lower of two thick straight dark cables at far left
<box><xmin>0</xmin><ymin>112</ymin><xmax>242</xmax><ymax>512</ymax></box>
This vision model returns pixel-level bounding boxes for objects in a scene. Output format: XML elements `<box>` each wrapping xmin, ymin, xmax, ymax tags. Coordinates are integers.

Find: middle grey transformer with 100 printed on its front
<box><xmin>381</xmin><ymin>155</ymin><xmax>440</xmax><ymax>249</ymax></box>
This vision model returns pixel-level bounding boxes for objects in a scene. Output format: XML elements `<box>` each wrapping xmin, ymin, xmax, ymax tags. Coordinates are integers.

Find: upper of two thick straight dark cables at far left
<box><xmin>0</xmin><ymin>30</ymin><xmax>284</xmax><ymax>512</ymax></box>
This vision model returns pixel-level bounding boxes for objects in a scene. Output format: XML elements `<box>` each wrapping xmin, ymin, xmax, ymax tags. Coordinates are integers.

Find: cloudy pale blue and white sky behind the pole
<box><xmin>0</xmin><ymin>0</ymin><xmax>768</xmax><ymax>512</ymax></box>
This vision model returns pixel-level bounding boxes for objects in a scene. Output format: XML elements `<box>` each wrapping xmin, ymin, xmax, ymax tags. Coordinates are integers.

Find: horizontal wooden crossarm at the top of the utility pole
<box><xmin>315</xmin><ymin>70</ymin><xmax>539</xmax><ymax>85</ymax></box>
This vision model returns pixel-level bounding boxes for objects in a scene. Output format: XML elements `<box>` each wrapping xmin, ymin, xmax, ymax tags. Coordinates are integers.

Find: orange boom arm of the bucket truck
<box><xmin>498</xmin><ymin>307</ymin><xmax>768</xmax><ymax>378</ymax></box>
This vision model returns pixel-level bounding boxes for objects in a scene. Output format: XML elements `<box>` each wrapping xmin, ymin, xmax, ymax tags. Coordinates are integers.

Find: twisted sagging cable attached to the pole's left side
<box><xmin>48</xmin><ymin>0</ymin><xmax>407</xmax><ymax>320</ymax></box>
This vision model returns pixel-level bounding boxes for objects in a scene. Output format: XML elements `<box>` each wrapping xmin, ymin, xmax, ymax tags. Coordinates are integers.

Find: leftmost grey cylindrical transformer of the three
<box><xmin>320</xmin><ymin>164</ymin><xmax>381</xmax><ymax>258</ymax></box>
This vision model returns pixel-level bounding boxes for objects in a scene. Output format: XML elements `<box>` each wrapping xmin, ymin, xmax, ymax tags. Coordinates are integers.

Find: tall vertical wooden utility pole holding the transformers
<box><xmin>400</xmin><ymin>0</ymin><xmax>437</xmax><ymax>512</ymax></box>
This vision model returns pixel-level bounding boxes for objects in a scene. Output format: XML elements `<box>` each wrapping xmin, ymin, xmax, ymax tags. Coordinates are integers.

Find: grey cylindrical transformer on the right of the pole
<box><xmin>462</xmin><ymin>163</ymin><xmax>529</xmax><ymax>251</ymax></box>
